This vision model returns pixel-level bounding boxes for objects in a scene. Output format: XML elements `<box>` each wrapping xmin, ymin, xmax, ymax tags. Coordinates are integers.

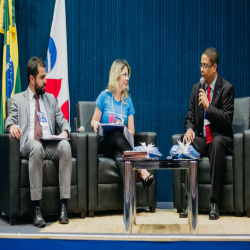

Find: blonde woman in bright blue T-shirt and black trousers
<box><xmin>91</xmin><ymin>59</ymin><xmax>155</xmax><ymax>187</ymax></box>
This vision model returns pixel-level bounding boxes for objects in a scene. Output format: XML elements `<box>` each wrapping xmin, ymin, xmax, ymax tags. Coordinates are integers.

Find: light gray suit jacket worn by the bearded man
<box><xmin>4</xmin><ymin>89</ymin><xmax>71</xmax><ymax>148</ymax></box>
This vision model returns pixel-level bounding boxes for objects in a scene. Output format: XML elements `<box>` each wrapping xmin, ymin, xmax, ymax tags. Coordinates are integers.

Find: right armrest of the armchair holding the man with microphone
<box><xmin>233</xmin><ymin>133</ymin><xmax>244</xmax><ymax>213</ymax></box>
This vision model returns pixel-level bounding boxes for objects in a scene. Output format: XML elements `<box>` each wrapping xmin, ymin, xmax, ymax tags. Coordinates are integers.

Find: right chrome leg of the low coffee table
<box><xmin>187</xmin><ymin>161</ymin><xmax>198</xmax><ymax>234</ymax></box>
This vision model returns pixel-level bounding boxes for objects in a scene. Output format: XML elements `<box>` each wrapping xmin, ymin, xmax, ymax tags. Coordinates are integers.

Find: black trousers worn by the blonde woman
<box><xmin>98</xmin><ymin>129</ymin><xmax>133</xmax><ymax>182</ymax></box>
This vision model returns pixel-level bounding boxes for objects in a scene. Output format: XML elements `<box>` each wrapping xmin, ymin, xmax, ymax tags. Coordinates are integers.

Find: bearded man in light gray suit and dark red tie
<box><xmin>5</xmin><ymin>57</ymin><xmax>72</xmax><ymax>227</ymax></box>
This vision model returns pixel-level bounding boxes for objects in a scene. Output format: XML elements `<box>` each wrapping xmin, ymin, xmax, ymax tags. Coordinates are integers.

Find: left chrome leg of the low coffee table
<box><xmin>123</xmin><ymin>161</ymin><xmax>135</xmax><ymax>233</ymax></box>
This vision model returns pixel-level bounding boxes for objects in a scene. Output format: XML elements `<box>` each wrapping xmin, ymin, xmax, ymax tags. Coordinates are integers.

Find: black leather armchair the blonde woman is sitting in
<box><xmin>75</xmin><ymin>102</ymin><xmax>157</xmax><ymax>217</ymax></box>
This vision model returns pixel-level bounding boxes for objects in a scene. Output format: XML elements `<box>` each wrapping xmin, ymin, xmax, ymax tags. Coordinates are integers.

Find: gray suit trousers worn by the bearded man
<box><xmin>21</xmin><ymin>139</ymin><xmax>72</xmax><ymax>201</ymax></box>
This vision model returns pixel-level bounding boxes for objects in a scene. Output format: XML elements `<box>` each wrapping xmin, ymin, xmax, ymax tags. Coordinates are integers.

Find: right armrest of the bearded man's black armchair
<box><xmin>71</xmin><ymin>133</ymin><xmax>88</xmax><ymax>212</ymax></box>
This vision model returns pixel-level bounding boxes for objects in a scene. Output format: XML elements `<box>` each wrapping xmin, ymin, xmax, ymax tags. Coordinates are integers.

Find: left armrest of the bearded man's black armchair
<box><xmin>0</xmin><ymin>134</ymin><xmax>20</xmax><ymax>217</ymax></box>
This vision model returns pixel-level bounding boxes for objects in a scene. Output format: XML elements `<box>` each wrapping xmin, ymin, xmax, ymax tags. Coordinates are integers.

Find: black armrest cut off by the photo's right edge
<box><xmin>244</xmin><ymin>129</ymin><xmax>250</xmax><ymax>213</ymax></box>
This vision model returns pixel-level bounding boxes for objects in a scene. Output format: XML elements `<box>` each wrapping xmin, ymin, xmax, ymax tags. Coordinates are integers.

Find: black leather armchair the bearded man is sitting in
<box><xmin>0</xmin><ymin>99</ymin><xmax>87</xmax><ymax>225</ymax></box>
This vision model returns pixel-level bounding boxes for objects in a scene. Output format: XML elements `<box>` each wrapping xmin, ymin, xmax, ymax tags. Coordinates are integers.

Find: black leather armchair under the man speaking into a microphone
<box><xmin>172</xmin><ymin>97</ymin><xmax>250</xmax><ymax>216</ymax></box>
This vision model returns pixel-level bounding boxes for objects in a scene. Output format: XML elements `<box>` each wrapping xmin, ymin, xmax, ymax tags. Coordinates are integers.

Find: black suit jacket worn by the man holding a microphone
<box><xmin>185</xmin><ymin>74</ymin><xmax>234</xmax><ymax>137</ymax></box>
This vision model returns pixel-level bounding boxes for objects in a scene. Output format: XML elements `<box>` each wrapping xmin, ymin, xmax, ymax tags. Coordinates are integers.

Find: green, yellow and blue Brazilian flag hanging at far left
<box><xmin>0</xmin><ymin>0</ymin><xmax>21</xmax><ymax>133</ymax></box>
